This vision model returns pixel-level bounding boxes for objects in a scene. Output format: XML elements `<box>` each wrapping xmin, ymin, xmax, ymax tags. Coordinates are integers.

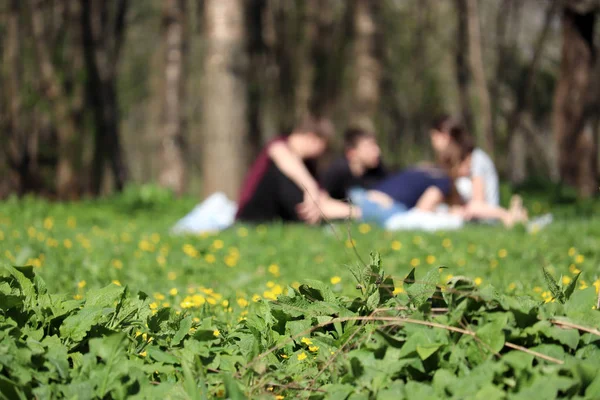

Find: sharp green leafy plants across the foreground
<box><xmin>0</xmin><ymin>253</ymin><xmax>600</xmax><ymax>399</ymax></box>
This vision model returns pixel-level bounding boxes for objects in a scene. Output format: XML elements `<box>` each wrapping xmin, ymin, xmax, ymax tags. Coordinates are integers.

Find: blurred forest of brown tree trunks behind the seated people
<box><xmin>0</xmin><ymin>0</ymin><xmax>600</xmax><ymax>199</ymax></box>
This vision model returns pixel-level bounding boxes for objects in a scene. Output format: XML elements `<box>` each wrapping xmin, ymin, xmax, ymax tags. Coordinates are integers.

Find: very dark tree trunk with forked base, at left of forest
<box><xmin>82</xmin><ymin>0</ymin><xmax>129</xmax><ymax>195</ymax></box>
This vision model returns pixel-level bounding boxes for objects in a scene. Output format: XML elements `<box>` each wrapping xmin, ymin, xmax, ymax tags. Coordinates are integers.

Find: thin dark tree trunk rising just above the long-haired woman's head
<box><xmin>455</xmin><ymin>0</ymin><xmax>473</xmax><ymax>132</ymax></box>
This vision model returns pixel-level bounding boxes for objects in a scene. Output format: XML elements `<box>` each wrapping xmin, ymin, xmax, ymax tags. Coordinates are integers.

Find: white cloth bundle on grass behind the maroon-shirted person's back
<box><xmin>171</xmin><ymin>192</ymin><xmax>238</xmax><ymax>234</ymax></box>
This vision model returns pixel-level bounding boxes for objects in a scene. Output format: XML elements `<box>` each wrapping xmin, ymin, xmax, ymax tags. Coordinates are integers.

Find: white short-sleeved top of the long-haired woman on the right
<box><xmin>456</xmin><ymin>148</ymin><xmax>500</xmax><ymax>206</ymax></box>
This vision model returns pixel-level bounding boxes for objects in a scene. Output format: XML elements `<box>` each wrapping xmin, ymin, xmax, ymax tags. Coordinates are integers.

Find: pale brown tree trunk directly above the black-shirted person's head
<box><xmin>351</xmin><ymin>0</ymin><xmax>382</xmax><ymax>130</ymax></box>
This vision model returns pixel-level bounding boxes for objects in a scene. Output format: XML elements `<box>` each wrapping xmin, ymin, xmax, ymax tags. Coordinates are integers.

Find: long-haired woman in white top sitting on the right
<box><xmin>430</xmin><ymin>116</ymin><xmax>527</xmax><ymax>226</ymax></box>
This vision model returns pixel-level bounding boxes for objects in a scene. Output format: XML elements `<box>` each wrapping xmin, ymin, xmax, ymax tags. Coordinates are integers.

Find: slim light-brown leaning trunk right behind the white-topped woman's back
<box><xmin>466</xmin><ymin>0</ymin><xmax>494</xmax><ymax>158</ymax></box>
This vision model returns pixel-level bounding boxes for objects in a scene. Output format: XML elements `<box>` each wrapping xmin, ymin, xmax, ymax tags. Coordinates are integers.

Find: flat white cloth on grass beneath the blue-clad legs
<box><xmin>385</xmin><ymin>208</ymin><xmax>465</xmax><ymax>232</ymax></box>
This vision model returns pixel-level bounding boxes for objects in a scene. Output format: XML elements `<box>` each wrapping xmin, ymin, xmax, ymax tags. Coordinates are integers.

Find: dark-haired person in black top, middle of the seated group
<box><xmin>321</xmin><ymin>128</ymin><xmax>387</xmax><ymax>200</ymax></box>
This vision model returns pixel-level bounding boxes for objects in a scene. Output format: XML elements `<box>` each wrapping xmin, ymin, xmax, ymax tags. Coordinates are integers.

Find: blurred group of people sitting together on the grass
<box><xmin>236</xmin><ymin>116</ymin><xmax>527</xmax><ymax>227</ymax></box>
